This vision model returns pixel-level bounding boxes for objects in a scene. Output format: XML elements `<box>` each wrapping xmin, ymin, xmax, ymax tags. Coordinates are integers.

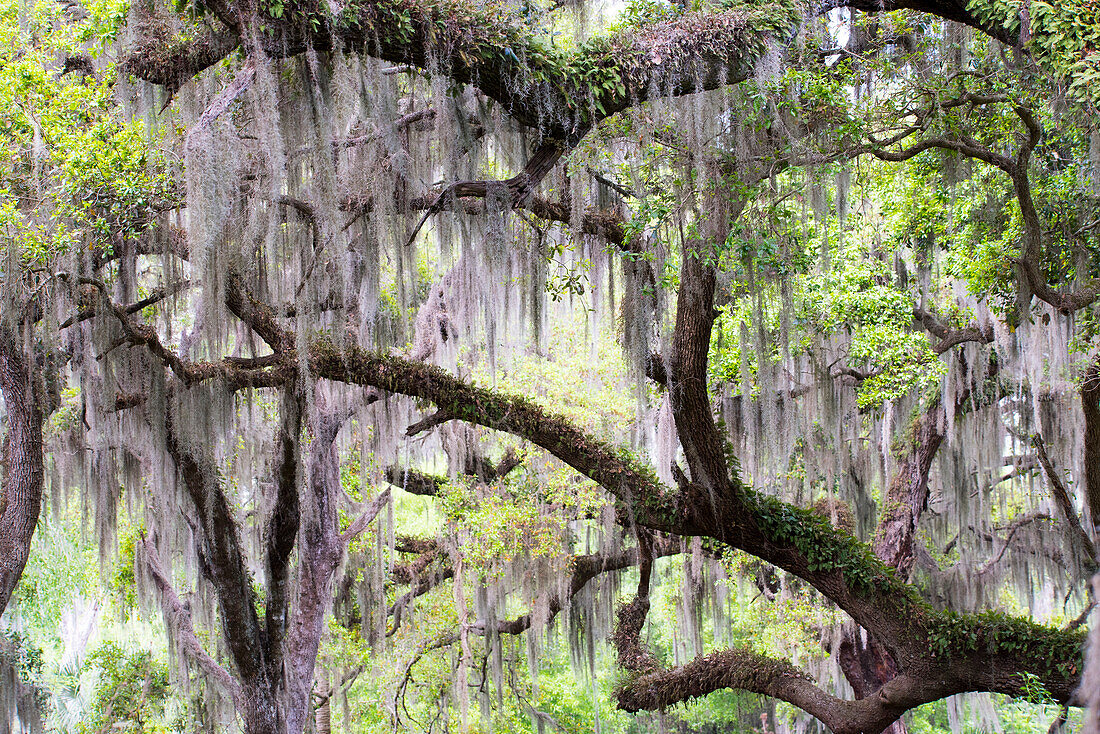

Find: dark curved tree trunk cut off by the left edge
<box><xmin>0</xmin><ymin>326</ymin><xmax>44</xmax><ymax>613</ymax></box>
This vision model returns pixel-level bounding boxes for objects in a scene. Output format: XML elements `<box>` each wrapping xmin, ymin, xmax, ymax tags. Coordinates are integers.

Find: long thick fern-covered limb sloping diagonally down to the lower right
<box><xmin>206</xmin><ymin>275</ymin><xmax>1080</xmax><ymax>722</ymax></box>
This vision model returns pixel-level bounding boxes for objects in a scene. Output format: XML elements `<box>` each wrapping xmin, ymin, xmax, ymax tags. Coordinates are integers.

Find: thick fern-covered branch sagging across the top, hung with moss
<box><xmin>123</xmin><ymin>0</ymin><xmax>783</xmax><ymax>145</ymax></box>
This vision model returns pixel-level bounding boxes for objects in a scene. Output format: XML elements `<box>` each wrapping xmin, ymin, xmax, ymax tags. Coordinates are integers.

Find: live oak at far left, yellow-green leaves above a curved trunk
<box><xmin>0</xmin><ymin>3</ymin><xmax>163</xmax><ymax>638</ymax></box>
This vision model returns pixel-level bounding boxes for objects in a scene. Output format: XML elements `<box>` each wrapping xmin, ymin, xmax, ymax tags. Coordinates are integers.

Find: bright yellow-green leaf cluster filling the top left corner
<box><xmin>0</xmin><ymin>0</ymin><xmax>167</xmax><ymax>274</ymax></box>
